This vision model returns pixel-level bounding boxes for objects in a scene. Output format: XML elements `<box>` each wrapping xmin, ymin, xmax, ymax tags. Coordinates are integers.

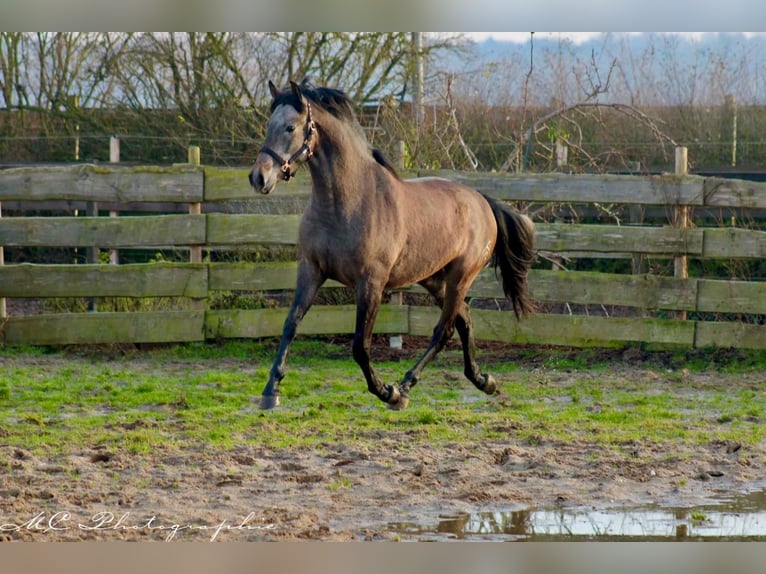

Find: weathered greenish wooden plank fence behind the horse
<box><xmin>0</xmin><ymin>158</ymin><xmax>766</xmax><ymax>349</ymax></box>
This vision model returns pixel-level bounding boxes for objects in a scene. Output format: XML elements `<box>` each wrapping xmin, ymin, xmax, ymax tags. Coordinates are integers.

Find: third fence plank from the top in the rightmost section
<box><xmin>697</xmin><ymin>279</ymin><xmax>766</xmax><ymax>315</ymax></box>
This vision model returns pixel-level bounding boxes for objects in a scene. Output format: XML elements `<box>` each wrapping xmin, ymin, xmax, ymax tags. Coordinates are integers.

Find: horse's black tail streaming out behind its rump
<box><xmin>484</xmin><ymin>195</ymin><xmax>535</xmax><ymax>318</ymax></box>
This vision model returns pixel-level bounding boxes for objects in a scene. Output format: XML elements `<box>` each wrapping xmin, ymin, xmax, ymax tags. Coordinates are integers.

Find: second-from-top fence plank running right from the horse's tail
<box><xmin>535</xmin><ymin>223</ymin><xmax>702</xmax><ymax>255</ymax></box>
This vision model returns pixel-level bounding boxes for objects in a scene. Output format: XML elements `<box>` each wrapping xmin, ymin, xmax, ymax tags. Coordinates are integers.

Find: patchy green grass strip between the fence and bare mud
<box><xmin>0</xmin><ymin>339</ymin><xmax>766</xmax><ymax>462</ymax></box>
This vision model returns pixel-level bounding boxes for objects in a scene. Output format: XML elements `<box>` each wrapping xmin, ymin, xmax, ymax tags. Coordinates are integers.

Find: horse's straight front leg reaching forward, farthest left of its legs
<box><xmin>260</xmin><ymin>260</ymin><xmax>325</xmax><ymax>409</ymax></box>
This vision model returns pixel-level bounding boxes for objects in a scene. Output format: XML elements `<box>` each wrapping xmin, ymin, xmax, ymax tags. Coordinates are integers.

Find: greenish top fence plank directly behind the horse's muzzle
<box><xmin>205</xmin><ymin>166</ymin><xmax>311</xmax><ymax>202</ymax></box>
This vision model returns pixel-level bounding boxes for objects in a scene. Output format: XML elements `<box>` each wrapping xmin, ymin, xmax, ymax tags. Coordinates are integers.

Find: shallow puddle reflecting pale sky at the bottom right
<box><xmin>389</xmin><ymin>491</ymin><xmax>766</xmax><ymax>541</ymax></box>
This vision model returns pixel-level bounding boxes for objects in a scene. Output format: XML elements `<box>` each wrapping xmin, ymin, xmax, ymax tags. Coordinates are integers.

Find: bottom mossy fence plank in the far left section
<box><xmin>2</xmin><ymin>310</ymin><xmax>205</xmax><ymax>345</ymax></box>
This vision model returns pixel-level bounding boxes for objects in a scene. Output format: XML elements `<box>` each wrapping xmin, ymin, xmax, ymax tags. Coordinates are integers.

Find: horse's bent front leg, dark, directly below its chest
<box><xmin>352</xmin><ymin>285</ymin><xmax>399</xmax><ymax>405</ymax></box>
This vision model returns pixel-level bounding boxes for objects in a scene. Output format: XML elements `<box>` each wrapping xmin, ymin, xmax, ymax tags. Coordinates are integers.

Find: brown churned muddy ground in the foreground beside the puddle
<box><xmin>0</xmin><ymin>342</ymin><xmax>766</xmax><ymax>541</ymax></box>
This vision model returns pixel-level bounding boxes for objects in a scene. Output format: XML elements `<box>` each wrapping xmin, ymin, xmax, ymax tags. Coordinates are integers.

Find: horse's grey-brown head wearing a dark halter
<box><xmin>250</xmin><ymin>81</ymin><xmax>316</xmax><ymax>194</ymax></box>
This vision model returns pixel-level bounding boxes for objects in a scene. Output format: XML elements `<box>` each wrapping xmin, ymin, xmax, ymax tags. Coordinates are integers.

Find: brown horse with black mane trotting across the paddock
<box><xmin>249</xmin><ymin>80</ymin><xmax>535</xmax><ymax>410</ymax></box>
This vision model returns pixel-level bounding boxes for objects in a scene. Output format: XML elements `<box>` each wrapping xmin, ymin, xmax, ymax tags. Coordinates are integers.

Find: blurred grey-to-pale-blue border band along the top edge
<box><xmin>6</xmin><ymin>0</ymin><xmax>766</xmax><ymax>32</ymax></box>
